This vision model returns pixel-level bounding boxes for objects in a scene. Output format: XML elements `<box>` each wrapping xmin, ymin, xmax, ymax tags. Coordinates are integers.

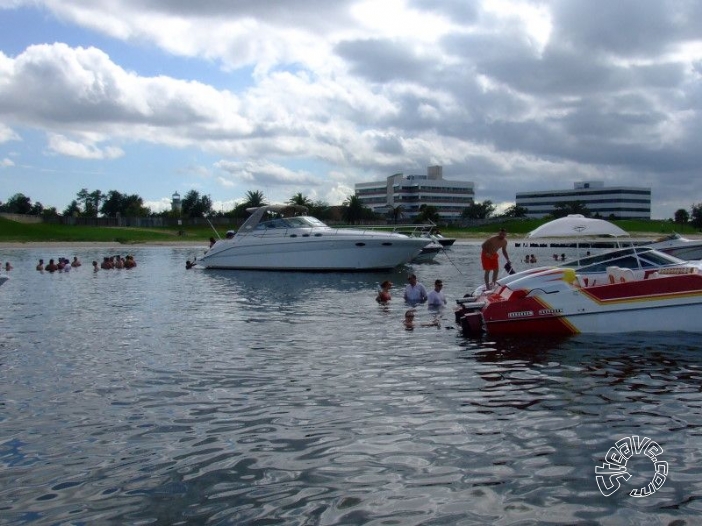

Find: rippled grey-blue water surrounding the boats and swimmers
<box><xmin>0</xmin><ymin>243</ymin><xmax>702</xmax><ymax>525</ymax></box>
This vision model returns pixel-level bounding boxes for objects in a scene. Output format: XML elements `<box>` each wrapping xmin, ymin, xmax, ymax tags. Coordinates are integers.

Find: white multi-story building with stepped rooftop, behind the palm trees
<box><xmin>355</xmin><ymin>166</ymin><xmax>475</xmax><ymax>221</ymax></box>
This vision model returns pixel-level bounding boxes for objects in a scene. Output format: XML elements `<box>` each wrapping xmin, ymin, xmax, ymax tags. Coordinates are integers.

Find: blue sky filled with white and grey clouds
<box><xmin>0</xmin><ymin>0</ymin><xmax>702</xmax><ymax>219</ymax></box>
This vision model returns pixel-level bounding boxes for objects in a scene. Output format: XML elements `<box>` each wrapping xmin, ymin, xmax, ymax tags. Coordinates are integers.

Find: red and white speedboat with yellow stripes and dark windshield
<box><xmin>456</xmin><ymin>216</ymin><xmax>702</xmax><ymax>336</ymax></box>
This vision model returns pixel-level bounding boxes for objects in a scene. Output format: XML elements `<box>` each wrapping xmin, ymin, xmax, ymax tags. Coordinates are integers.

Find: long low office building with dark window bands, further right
<box><xmin>516</xmin><ymin>181</ymin><xmax>651</xmax><ymax>219</ymax></box>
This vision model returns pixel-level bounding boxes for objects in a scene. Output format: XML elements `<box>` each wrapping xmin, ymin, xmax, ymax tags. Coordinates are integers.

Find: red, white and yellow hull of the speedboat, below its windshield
<box><xmin>457</xmin><ymin>267</ymin><xmax>702</xmax><ymax>336</ymax></box>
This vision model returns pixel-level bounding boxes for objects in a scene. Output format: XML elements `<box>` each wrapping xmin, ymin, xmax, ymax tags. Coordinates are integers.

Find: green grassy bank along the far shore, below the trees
<box><xmin>0</xmin><ymin>218</ymin><xmax>700</xmax><ymax>245</ymax></box>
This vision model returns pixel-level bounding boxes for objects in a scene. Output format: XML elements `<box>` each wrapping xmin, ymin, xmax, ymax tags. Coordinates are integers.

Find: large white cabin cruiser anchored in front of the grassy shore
<box><xmin>196</xmin><ymin>205</ymin><xmax>427</xmax><ymax>271</ymax></box>
